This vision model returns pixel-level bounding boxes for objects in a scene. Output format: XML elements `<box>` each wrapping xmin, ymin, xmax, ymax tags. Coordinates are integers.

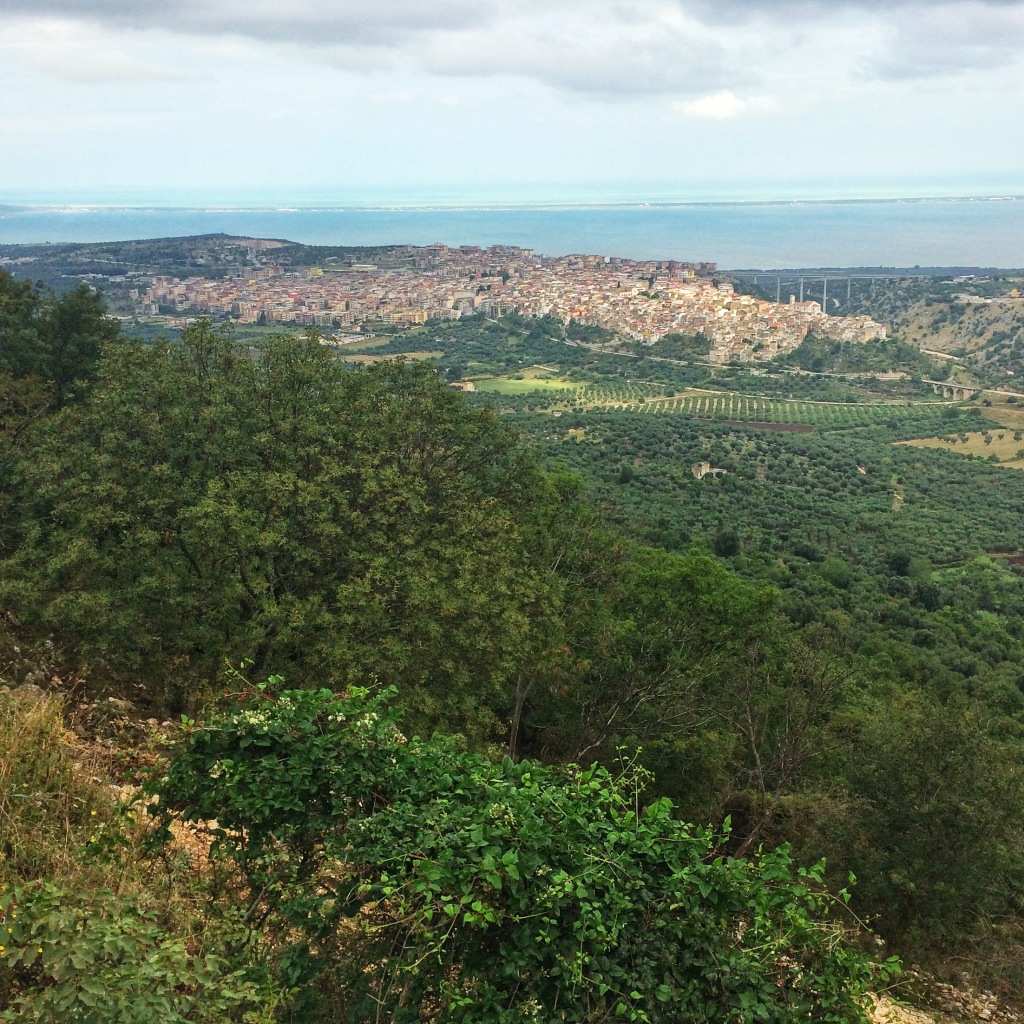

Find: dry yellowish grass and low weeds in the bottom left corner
<box><xmin>0</xmin><ymin>688</ymin><xmax>280</xmax><ymax>1024</ymax></box>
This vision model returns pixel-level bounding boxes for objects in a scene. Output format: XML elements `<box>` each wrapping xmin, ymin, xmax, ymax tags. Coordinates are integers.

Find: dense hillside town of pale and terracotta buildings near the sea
<box><xmin>132</xmin><ymin>244</ymin><xmax>886</xmax><ymax>362</ymax></box>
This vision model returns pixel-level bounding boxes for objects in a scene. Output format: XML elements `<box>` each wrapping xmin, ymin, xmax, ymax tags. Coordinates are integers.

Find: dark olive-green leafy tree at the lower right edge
<box><xmin>817</xmin><ymin>692</ymin><xmax>1024</xmax><ymax>946</ymax></box>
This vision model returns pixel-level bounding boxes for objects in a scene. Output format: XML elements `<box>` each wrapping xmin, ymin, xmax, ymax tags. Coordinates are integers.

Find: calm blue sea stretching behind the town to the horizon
<box><xmin>0</xmin><ymin>194</ymin><xmax>1024</xmax><ymax>269</ymax></box>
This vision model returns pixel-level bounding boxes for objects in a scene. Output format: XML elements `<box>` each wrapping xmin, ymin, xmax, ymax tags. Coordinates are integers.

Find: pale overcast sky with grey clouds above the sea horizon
<box><xmin>0</xmin><ymin>0</ymin><xmax>1024</xmax><ymax>203</ymax></box>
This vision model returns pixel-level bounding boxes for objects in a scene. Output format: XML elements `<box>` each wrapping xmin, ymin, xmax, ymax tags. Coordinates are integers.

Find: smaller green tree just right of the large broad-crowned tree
<box><xmin>534</xmin><ymin>548</ymin><xmax>772</xmax><ymax>760</ymax></box>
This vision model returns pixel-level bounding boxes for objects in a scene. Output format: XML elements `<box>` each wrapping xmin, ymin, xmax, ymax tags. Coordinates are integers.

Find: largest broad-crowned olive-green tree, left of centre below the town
<box><xmin>0</xmin><ymin>325</ymin><xmax>549</xmax><ymax>733</ymax></box>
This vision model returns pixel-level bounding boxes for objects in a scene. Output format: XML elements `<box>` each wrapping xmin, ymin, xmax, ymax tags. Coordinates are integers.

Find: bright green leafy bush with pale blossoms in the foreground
<box><xmin>156</xmin><ymin>681</ymin><xmax>891</xmax><ymax>1024</ymax></box>
